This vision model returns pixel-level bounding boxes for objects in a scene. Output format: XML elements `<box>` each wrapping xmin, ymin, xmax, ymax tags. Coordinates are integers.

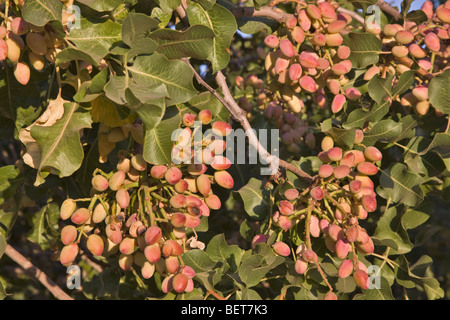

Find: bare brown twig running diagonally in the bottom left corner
<box><xmin>5</xmin><ymin>244</ymin><xmax>73</xmax><ymax>300</ymax></box>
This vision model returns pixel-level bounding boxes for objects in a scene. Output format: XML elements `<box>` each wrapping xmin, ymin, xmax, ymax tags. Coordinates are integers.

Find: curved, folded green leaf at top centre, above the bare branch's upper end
<box><xmin>187</xmin><ymin>3</ymin><xmax>237</xmax><ymax>73</ymax></box>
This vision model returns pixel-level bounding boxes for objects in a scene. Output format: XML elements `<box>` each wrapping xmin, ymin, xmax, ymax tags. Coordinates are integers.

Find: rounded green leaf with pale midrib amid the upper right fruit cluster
<box><xmin>343</xmin><ymin>32</ymin><xmax>381</xmax><ymax>69</ymax></box>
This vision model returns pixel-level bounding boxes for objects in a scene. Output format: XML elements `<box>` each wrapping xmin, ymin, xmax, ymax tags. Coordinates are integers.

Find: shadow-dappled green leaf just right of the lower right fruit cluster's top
<box><xmin>380</xmin><ymin>163</ymin><xmax>423</xmax><ymax>207</ymax></box>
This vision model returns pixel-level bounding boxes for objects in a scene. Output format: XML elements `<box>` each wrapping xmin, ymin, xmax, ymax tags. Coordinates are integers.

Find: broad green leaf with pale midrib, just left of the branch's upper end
<box><xmin>128</xmin><ymin>52</ymin><xmax>197</xmax><ymax>105</ymax></box>
